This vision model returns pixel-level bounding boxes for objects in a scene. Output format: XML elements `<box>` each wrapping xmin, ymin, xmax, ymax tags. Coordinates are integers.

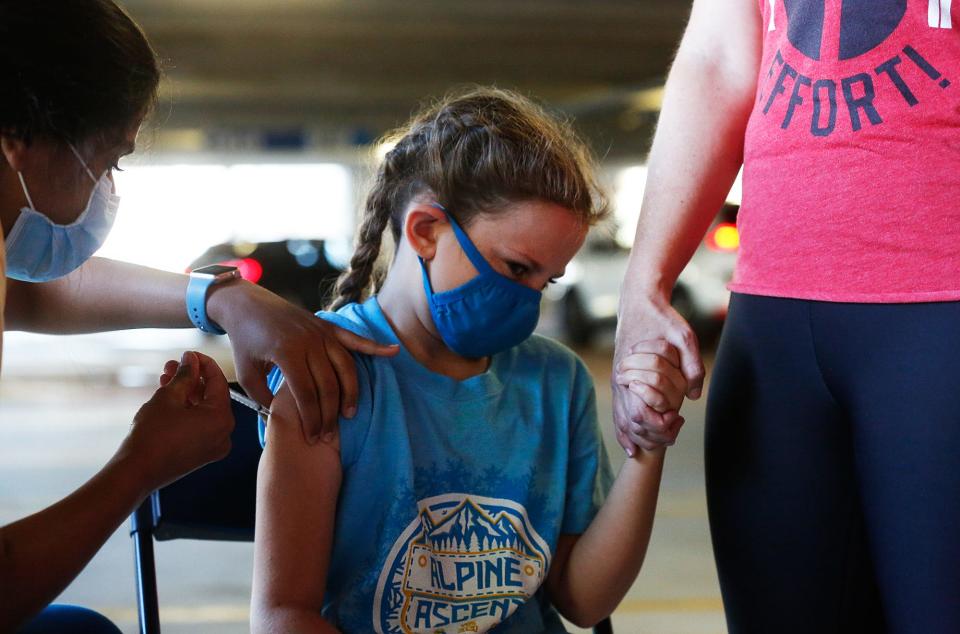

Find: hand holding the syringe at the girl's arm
<box><xmin>118</xmin><ymin>352</ymin><xmax>234</xmax><ymax>492</ymax></box>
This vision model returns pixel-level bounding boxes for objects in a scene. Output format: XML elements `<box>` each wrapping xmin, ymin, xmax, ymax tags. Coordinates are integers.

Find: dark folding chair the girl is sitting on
<box><xmin>130</xmin><ymin>384</ymin><xmax>613</xmax><ymax>634</ymax></box>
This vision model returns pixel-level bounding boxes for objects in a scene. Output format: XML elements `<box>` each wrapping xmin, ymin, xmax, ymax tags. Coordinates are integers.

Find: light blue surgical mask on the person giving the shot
<box><xmin>6</xmin><ymin>145</ymin><xmax>120</xmax><ymax>282</ymax></box>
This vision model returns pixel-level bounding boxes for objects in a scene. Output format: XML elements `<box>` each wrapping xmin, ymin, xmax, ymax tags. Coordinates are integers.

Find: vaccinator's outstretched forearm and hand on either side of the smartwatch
<box><xmin>6</xmin><ymin>258</ymin><xmax>398</xmax><ymax>439</ymax></box>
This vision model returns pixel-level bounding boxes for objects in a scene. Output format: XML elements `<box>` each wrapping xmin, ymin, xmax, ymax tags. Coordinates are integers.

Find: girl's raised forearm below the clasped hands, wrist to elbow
<box><xmin>547</xmin><ymin>448</ymin><xmax>665</xmax><ymax>627</ymax></box>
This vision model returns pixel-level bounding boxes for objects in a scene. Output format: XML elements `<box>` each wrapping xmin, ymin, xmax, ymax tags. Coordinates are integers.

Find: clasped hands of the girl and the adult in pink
<box><xmin>610</xmin><ymin>294</ymin><xmax>704</xmax><ymax>456</ymax></box>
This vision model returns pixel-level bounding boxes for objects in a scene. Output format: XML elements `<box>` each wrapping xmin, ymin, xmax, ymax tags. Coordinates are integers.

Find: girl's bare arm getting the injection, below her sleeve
<box><xmin>251</xmin><ymin>386</ymin><xmax>342</xmax><ymax>634</ymax></box>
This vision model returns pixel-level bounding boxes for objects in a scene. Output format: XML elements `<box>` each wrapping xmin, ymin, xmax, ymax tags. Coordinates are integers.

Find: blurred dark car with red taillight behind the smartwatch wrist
<box><xmin>188</xmin><ymin>240</ymin><xmax>351</xmax><ymax>312</ymax></box>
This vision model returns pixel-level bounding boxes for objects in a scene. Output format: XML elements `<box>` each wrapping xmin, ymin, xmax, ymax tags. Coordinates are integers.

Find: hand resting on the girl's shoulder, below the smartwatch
<box><xmin>207</xmin><ymin>281</ymin><xmax>399</xmax><ymax>443</ymax></box>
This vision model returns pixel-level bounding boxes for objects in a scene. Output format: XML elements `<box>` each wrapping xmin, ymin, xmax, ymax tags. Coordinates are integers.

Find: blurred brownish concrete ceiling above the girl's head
<box><xmin>125</xmin><ymin>0</ymin><xmax>689</xmax><ymax>155</ymax></box>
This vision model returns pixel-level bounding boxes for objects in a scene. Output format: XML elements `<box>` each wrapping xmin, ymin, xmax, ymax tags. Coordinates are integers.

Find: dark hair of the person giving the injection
<box><xmin>0</xmin><ymin>0</ymin><xmax>160</xmax><ymax>143</ymax></box>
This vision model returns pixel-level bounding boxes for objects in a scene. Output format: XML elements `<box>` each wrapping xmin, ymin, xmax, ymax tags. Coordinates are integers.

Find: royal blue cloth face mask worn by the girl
<box><xmin>420</xmin><ymin>205</ymin><xmax>542</xmax><ymax>358</ymax></box>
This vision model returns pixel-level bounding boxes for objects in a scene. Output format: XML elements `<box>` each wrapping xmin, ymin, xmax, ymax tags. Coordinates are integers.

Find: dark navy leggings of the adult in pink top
<box><xmin>706</xmin><ymin>294</ymin><xmax>960</xmax><ymax>634</ymax></box>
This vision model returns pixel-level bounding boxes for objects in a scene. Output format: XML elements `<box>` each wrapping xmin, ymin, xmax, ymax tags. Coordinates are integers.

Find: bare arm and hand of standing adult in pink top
<box><xmin>613</xmin><ymin>0</ymin><xmax>763</xmax><ymax>451</ymax></box>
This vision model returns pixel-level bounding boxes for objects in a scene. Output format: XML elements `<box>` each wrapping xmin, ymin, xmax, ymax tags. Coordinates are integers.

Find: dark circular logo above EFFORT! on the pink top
<box><xmin>783</xmin><ymin>0</ymin><xmax>907</xmax><ymax>61</ymax></box>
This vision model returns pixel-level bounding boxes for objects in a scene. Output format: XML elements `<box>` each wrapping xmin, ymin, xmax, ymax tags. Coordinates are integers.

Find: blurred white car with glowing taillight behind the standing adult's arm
<box><xmin>548</xmin><ymin>204</ymin><xmax>740</xmax><ymax>345</ymax></box>
